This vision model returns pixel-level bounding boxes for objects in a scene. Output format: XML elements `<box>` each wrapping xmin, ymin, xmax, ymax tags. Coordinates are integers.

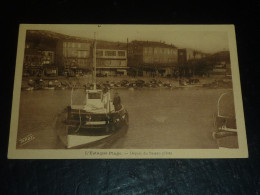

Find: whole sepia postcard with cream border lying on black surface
<box><xmin>8</xmin><ymin>24</ymin><xmax>248</xmax><ymax>159</ymax></box>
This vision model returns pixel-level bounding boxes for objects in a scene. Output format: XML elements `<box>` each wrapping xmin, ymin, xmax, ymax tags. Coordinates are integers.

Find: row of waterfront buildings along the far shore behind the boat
<box><xmin>24</xmin><ymin>30</ymin><xmax>230</xmax><ymax>76</ymax></box>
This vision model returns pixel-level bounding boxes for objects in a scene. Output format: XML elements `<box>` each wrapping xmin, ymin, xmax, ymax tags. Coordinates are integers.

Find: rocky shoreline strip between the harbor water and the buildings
<box><xmin>21</xmin><ymin>76</ymin><xmax>232</xmax><ymax>90</ymax></box>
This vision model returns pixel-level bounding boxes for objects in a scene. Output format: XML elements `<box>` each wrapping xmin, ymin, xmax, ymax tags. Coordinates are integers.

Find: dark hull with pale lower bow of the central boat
<box><xmin>56</xmin><ymin>107</ymin><xmax>128</xmax><ymax>148</ymax></box>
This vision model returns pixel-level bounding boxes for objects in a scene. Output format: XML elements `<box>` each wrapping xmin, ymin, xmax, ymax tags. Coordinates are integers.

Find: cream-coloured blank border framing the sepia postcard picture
<box><xmin>8</xmin><ymin>24</ymin><xmax>248</xmax><ymax>159</ymax></box>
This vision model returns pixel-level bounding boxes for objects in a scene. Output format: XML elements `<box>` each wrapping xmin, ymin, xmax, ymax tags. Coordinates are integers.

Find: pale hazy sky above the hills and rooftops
<box><xmin>42</xmin><ymin>25</ymin><xmax>229</xmax><ymax>53</ymax></box>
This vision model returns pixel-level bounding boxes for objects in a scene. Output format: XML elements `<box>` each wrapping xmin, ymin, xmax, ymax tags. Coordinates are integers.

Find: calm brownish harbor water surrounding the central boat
<box><xmin>17</xmin><ymin>87</ymin><xmax>236</xmax><ymax>149</ymax></box>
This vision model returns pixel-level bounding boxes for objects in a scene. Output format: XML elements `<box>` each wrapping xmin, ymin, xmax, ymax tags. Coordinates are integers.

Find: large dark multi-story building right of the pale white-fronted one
<box><xmin>128</xmin><ymin>41</ymin><xmax>177</xmax><ymax>76</ymax></box>
